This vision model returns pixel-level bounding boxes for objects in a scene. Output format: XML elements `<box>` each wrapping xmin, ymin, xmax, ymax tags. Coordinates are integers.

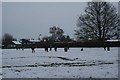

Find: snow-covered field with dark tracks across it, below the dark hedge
<box><xmin>2</xmin><ymin>48</ymin><xmax>118</xmax><ymax>78</ymax></box>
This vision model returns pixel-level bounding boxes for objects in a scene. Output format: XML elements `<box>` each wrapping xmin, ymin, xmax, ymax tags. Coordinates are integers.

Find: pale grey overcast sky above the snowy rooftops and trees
<box><xmin>2</xmin><ymin>2</ymin><xmax>118</xmax><ymax>39</ymax></box>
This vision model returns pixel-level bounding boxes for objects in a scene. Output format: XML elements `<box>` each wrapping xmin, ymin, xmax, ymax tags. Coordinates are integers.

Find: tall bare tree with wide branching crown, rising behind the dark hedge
<box><xmin>75</xmin><ymin>2</ymin><xmax>119</xmax><ymax>41</ymax></box>
